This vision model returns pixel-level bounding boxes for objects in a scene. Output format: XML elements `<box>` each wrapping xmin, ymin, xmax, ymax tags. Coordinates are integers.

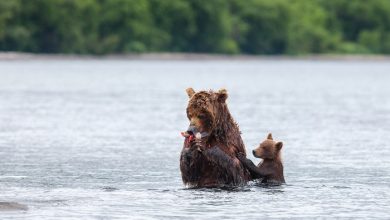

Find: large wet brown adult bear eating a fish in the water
<box><xmin>180</xmin><ymin>88</ymin><xmax>250</xmax><ymax>187</ymax></box>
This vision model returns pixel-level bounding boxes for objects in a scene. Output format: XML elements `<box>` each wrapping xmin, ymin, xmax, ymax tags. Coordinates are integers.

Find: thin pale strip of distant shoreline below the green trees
<box><xmin>0</xmin><ymin>52</ymin><xmax>390</xmax><ymax>61</ymax></box>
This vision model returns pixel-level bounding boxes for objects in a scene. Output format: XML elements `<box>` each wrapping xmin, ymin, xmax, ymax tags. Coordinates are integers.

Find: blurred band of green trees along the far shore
<box><xmin>0</xmin><ymin>0</ymin><xmax>390</xmax><ymax>54</ymax></box>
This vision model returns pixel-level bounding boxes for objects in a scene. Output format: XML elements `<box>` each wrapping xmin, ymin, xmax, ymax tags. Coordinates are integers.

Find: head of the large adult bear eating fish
<box><xmin>186</xmin><ymin>88</ymin><xmax>230</xmax><ymax>138</ymax></box>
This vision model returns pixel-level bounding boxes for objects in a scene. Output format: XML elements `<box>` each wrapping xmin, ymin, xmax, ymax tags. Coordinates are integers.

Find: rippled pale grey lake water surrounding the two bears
<box><xmin>0</xmin><ymin>59</ymin><xmax>390</xmax><ymax>219</ymax></box>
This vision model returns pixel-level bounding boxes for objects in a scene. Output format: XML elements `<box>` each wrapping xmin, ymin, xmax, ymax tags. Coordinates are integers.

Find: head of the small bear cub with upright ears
<box><xmin>252</xmin><ymin>133</ymin><xmax>283</xmax><ymax>159</ymax></box>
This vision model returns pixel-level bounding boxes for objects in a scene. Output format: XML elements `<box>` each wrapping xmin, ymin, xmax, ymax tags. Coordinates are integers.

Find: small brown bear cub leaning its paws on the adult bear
<box><xmin>237</xmin><ymin>133</ymin><xmax>285</xmax><ymax>185</ymax></box>
